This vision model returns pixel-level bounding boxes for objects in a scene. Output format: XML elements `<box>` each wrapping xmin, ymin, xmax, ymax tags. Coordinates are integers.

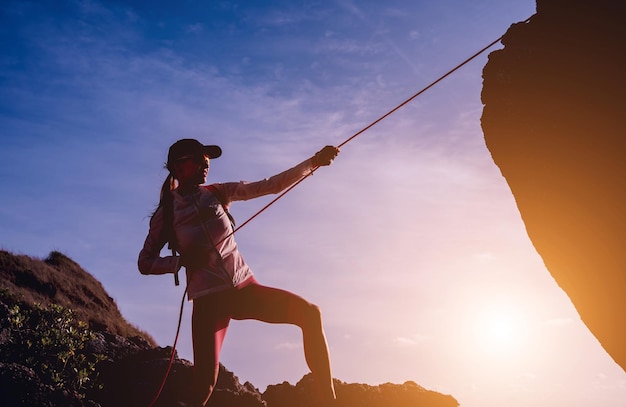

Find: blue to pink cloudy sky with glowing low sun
<box><xmin>0</xmin><ymin>0</ymin><xmax>626</xmax><ymax>407</ymax></box>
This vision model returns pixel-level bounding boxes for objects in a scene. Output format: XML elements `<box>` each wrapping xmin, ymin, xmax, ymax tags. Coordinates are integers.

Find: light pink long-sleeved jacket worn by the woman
<box><xmin>138</xmin><ymin>159</ymin><xmax>313</xmax><ymax>300</ymax></box>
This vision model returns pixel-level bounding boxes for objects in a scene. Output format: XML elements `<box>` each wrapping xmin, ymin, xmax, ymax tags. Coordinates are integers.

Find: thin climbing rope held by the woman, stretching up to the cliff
<box><xmin>150</xmin><ymin>18</ymin><xmax>530</xmax><ymax>407</ymax></box>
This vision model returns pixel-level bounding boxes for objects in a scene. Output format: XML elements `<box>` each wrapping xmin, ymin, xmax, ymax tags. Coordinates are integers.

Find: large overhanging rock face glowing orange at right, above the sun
<box><xmin>482</xmin><ymin>0</ymin><xmax>626</xmax><ymax>368</ymax></box>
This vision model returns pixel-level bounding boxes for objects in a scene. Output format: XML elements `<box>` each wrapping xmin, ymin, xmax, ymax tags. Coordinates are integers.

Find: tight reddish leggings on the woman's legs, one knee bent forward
<box><xmin>192</xmin><ymin>277</ymin><xmax>335</xmax><ymax>404</ymax></box>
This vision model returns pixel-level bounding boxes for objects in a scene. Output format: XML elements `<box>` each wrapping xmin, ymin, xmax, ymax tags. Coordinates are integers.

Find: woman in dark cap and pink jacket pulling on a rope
<box><xmin>138</xmin><ymin>139</ymin><xmax>339</xmax><ymax>406</ymax></box>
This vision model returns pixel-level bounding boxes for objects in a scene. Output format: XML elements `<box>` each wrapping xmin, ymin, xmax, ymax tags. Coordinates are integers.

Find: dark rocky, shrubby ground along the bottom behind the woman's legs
<box><xmin>0</xmin><ymin>250</ymin><xmax>458</xmax><ymax>407</ymax></box>
